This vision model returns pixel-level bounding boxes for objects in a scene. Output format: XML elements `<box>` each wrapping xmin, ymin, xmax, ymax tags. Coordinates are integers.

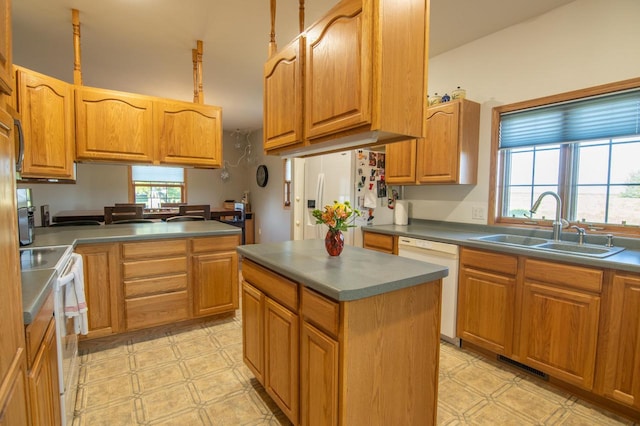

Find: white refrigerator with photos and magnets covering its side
<box><xmin>294</xmin><ymin>149</ymin><xmax>393</xmax><ymax>247</ymax></box>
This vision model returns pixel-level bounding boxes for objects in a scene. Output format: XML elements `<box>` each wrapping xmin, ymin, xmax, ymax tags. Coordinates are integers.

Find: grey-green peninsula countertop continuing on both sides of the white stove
<box><xmin>22</xmin><ymin>220</ymin><xmax>242</xmax><ymax>325</ymax></box>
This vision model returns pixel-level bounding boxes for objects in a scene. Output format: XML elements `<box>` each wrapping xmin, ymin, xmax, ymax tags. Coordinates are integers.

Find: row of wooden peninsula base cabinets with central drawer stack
<box><xmin>75</xmin><ymin>235</ymin><xmax>240</xmax><ymax>338</ymax></box>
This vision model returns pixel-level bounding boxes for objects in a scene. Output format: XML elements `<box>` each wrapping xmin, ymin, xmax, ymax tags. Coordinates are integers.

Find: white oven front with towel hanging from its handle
<box><xmin>53</xmin><ymin>253</ymin><xmax>86</xmax><ymax>426</ymax></box>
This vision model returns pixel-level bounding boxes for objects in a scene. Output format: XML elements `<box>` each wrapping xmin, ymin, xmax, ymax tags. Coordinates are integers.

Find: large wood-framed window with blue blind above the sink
<box><xmin>490</xmin><ymin>79</ymin><xmax>640</xmax><ymax>235</ymax></box>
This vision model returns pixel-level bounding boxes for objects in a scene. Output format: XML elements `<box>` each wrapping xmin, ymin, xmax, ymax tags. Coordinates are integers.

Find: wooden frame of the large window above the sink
<box><xmin>488</xmin><ymin>78</ymin><xmax>640</xmax><ymax>237</ymax></box>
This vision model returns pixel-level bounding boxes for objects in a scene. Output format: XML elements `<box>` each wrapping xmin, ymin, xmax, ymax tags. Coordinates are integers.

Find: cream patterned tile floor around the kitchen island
<box><xmin>73</xmin><ymin>314</ymin><xmax>633</xmax><ymax>426</ymax></box>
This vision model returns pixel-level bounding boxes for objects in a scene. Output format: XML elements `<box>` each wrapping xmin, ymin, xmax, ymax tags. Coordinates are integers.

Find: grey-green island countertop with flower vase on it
<box><xmin>237</xmin><ymin>240</ymin><xmax>449</xmax><ymax>301</ymax></box>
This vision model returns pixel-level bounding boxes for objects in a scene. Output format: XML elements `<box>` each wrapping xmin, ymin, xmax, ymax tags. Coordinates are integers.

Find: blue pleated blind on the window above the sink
<box><xmin>499</xmin><ymin>89</ymin><xmax>640</xmax><ymax>149</ymax></box>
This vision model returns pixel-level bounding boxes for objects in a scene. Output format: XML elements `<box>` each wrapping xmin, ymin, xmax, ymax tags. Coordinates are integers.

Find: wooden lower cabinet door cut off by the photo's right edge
<box><xmin>602</xmin><ymin>273</ymin><xmax>640</xmax><ymax>411</ymax></box>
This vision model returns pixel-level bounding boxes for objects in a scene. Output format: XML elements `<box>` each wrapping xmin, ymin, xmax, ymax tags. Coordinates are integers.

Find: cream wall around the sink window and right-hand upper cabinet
<box><xmin>404</xmin><ymin>0</ymin><xmax>640</xmax><ymax>223</ymax></box>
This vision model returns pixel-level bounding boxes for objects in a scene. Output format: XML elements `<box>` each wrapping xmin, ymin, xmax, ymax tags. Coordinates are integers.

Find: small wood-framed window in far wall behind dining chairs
<box><xmin>129</xmin><ymin>166</ymin><xmax>187</xmax><ymax>209</ymax></box>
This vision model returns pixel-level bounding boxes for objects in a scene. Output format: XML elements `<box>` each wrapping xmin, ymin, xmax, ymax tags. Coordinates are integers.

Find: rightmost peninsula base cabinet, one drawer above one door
<box><xmin>190</xmin><ymin>236</ymin><xmax>240</xmax><ymax>317</ymax></box>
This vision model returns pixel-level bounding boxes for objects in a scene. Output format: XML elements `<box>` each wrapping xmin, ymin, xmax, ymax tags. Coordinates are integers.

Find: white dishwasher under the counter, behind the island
<box><xmin>398</xmin><ymin>237</ymin><xmax>460</xmax><ymax>346</ymax></box>
